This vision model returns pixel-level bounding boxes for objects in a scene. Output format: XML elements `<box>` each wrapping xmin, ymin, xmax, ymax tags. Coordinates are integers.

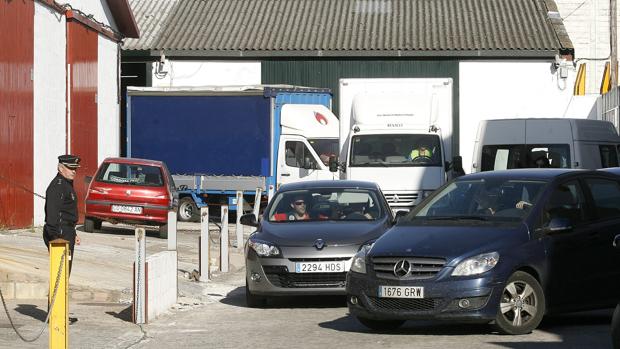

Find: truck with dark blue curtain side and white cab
<box><xmin>127</xmin><ymin>86</ymin><xmax>339</xmax><ymax>221</ymax></box>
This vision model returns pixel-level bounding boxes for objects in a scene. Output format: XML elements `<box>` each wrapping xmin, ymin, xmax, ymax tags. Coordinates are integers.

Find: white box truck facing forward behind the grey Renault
<box><xmin>339</xmin><ymin>78</ymin><xmax>453</xmax><ymax>211</ymax></box>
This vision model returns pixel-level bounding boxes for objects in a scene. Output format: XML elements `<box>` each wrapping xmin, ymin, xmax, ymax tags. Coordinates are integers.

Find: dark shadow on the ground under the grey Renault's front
<box><xmin>220</xmin><ymin>286</ymin><xmax>347</xmax><ymax>309</ymax></box>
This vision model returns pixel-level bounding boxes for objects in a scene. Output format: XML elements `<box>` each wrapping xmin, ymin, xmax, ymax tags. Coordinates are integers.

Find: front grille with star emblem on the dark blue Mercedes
<box><xmin>372</xmin><ymin>257</ymin><xmax>446</xmax><ymax>280</ymax></box>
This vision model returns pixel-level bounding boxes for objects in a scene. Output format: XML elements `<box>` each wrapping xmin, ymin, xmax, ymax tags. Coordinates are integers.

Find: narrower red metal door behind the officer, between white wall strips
<box><xmin>67</xmin><ymin>20</ymin><xmax>97</xmax><ymax>221</ymax></box>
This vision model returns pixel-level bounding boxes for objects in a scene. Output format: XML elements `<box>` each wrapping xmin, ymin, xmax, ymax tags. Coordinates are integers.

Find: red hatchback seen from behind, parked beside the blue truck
<box><xmin>84</xmin><ymin>158</ymin><xmax>178</xmax><ymax>238</ymax></box>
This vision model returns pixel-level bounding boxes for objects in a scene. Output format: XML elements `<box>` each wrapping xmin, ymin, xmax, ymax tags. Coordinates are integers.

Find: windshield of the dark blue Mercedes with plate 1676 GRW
<box><xmin>403</xmin><ymin>179</ymin><xmax>546</xmax><ymax>221</ymax></box>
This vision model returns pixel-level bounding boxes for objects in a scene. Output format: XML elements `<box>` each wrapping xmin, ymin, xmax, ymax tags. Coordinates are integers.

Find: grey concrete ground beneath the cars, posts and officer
<box><xmin>0</xmin><ymin>225</ymin><xmax>611</xmax><ymax>349</ymax></box>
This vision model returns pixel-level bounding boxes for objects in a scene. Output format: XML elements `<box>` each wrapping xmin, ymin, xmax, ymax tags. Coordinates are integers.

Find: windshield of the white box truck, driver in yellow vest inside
<box><xmin>349</xmin><ymin>134</ymin><xmax>442</xmax><ymax>167</ymax></box>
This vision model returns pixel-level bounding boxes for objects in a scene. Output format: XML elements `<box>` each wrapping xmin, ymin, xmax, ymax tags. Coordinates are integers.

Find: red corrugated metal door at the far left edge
<box><xmin>0</xmin><ymin>0</ymin><xmax>34</xmax><ymax>227</ymax></box>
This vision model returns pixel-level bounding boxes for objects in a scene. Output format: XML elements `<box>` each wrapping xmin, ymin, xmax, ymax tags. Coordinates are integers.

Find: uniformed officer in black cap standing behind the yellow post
<box><xmin>43</xmin><ymin>155</ymin><xmax>80</xmax><ymax>274</ymax></box>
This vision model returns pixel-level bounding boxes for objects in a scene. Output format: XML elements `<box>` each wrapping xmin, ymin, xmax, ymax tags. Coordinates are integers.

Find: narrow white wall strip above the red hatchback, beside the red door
<box><xmin>97</xmin><ymin>35</ymin><xmax>120</xmax><ymax>163</ymax></box>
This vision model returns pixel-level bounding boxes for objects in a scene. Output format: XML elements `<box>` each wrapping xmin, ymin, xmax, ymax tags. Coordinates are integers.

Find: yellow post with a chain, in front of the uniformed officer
<box><xmin>48</xmin><ymin>239</ymin><xmax>70</xmax><ymax>349</ymax></box>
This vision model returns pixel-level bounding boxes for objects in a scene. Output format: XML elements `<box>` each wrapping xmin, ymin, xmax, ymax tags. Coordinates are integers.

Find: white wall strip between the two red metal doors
<box><xmin>33</xmin><ymin>2</ymin><xmax>67</xmax><ymax>225</ymax></box>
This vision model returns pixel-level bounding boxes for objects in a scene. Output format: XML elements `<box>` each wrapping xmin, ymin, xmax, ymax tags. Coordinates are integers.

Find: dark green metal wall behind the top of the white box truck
<box><xmin>261</xmin><ymin>59</ymin><xmax>459</xmax><ymax>154</ymax></box>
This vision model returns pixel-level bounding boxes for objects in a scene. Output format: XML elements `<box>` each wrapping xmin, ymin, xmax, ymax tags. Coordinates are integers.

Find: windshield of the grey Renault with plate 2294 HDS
<box><xmin>269</xmin><ymin>188</ymin><xmax>387</xmax><ymax>222</ymax></box>
